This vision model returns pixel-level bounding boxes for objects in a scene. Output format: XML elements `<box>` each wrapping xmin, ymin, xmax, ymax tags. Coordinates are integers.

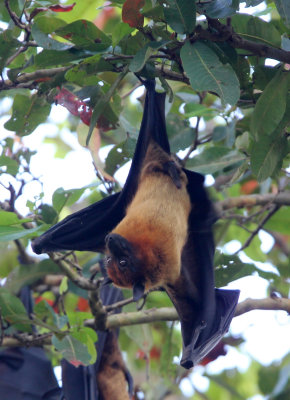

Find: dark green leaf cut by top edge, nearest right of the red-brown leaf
<box><xmin>163</xmin><ymin>0</ymin><xmax>196</xmax><ymax>34</ymax></box>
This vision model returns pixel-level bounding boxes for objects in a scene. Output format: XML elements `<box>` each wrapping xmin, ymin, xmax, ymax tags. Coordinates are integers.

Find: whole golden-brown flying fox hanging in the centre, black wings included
<box><xmin>32</xmin><ymin>81</ymin><xmax>239</xmax><ymax>368</ymax></box>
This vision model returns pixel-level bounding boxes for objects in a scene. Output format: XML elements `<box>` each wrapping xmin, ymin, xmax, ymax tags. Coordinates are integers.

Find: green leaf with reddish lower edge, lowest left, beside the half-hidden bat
<box><xmin>52</xmin><ymin>335</ymin><xmax>92</xmax><ymax>367</ymax></box>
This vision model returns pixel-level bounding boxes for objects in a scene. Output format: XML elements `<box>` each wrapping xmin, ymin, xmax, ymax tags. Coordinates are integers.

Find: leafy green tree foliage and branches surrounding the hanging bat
<box><xmin>0</xmin><ymin>0</ymin><xmax>290</xmax><ymax>400</ymax></box>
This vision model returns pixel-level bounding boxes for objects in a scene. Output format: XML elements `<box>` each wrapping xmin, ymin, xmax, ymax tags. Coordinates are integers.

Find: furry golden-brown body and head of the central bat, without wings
<box><xmin>106</xmin><ymin>142</ymin><xmax>191</xmax><ymax>300</ymax></box>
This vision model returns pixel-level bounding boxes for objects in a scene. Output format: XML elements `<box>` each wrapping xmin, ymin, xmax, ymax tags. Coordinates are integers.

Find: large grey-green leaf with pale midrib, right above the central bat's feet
<box><xmin>180</xmin><ymin>42</ymin><xmax>240</xmax><ymax>104</ymax></box>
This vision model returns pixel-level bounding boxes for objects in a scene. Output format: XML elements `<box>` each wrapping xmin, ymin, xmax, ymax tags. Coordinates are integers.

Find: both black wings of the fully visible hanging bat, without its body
<box><xmin>32</xmin><ymin>81</ymin><xmax>239</xmax><ymax>368</ymax></box>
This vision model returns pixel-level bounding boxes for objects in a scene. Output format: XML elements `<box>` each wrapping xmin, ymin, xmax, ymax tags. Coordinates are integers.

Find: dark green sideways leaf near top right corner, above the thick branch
<box><xmin>231</xmin><ymin>14</ymin><xmax>281</xmax><ymax>47</ymax></box>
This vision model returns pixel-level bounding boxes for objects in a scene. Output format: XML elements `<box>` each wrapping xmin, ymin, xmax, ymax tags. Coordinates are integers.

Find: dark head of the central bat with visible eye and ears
<box><xmin>106</xmin><ymin>233</ymin><xmax>145</xmax><ymax>300</ymax></box>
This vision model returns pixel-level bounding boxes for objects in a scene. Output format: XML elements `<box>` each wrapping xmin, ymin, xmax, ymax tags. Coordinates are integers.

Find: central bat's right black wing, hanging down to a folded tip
<box><xmin>167</xmin><ymin>170</ymin><xmax>239</xmax><ymax>368</ymax></box>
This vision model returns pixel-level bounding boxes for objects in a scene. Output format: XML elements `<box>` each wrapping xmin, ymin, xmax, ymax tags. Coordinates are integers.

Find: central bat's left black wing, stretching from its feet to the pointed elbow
<box><xmin>32</xmin><ymin>81</ymin><xmax>170</xmax><ymax>254</ymax></box>
